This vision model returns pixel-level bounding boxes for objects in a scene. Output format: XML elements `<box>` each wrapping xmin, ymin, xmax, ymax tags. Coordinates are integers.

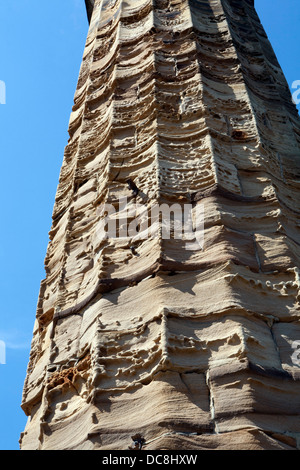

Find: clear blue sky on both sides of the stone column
<box><xmin>0</xmin><ymin>0</ymin><xmax>300</xmax><ymax>450</ymax></box>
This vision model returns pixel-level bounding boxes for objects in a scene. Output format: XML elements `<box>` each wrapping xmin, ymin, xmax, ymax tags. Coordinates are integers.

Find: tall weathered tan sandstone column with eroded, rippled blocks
<box><xmin>20</xmin><ymin>0</ymin><xmax>300</xmax><ymax>450</ymax></box>
